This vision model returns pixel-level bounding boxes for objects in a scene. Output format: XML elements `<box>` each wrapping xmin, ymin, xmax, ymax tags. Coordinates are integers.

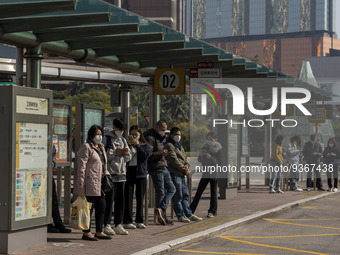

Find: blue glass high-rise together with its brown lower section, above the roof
<box><xmin>185</xmin><ymin>0</ymin><xmax>340</xmax><ymax>77</ymax></box>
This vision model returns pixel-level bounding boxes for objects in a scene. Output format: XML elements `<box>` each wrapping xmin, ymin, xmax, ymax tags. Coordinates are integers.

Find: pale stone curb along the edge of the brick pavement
<box><xmin>132</xmin><ymin>193</ymin><xmax>334</xmax><ymax>255</ymax></box>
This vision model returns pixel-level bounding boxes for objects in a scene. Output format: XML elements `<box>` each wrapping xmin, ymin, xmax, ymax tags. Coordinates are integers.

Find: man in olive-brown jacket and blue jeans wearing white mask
<box><xmin>164</xmin><ymin>127</ymin><xmax>202</xmax><ymax>223</ymax></box>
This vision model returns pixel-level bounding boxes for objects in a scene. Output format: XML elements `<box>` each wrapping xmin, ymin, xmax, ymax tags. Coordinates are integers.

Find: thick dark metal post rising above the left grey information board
<box><xmin>25</xmin><ymin>46</ymin><xmax>43</xmax><ymax>89</ymax></box>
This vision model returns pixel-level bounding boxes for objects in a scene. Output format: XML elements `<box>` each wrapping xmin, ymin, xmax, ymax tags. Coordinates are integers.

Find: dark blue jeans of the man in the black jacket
<box><xmin>150</xmin><ymin>167</ymin><xmax>176</xmax><ymax>212</ymax></box>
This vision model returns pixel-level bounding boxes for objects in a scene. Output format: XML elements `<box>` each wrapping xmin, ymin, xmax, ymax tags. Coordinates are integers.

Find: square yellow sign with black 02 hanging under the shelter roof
<box><xmin>154</xmin><ymin>68</ymin><xmax>185</xmax><ymax>95</ymax></box>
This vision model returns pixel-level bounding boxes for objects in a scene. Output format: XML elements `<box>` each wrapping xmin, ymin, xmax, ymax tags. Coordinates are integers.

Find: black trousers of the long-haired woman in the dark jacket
<box><xmin>123</xmin><ymin>166</ymin><xmax>146</xmax><ymax>224</ymax></box>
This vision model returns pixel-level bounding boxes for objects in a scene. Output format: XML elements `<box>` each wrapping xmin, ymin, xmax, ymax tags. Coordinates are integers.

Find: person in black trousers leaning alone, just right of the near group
<box><xmin>190</xmin><ymin>132</ymin><xmax>222</xmax><ymax>218</ymax></box>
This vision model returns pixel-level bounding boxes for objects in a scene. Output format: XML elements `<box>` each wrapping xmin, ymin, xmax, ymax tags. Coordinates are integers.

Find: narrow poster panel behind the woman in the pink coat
<box><xmin>52</xmin><ymin>104</ymin><xmax>70</xmax><ymax>163</ymax></box>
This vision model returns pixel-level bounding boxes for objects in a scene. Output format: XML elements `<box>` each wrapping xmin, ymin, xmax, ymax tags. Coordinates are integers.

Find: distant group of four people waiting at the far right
<box><xmin>269</xmin><ymin>134</ymin><xmax>340</xmax><ymax>194</ymax></box>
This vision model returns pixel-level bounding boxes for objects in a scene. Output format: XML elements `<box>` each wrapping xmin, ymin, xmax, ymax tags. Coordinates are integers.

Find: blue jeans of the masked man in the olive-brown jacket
<box><xmin>171</xmin><ymin>173</ymin><xmax>192</xmax><ymax>218</ymax></box>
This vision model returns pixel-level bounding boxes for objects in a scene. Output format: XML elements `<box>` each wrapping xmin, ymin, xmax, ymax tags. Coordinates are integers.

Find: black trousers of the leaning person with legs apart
<box><xmin>190</xmin><ymin>178</ymin><xmax>218</xmax><ymax>215</ymax></box>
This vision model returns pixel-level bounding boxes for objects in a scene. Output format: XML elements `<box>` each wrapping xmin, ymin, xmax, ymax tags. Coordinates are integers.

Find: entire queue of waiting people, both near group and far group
<box><xmin>67</xmin><ymin>118</ymin><xmax>340</xmax><ymax>241</ymax></box>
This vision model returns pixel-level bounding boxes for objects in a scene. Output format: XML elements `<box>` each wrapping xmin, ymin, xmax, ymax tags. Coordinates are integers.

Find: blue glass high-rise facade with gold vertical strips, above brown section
<box><xmin>186</xmin><ymin>0</ymin><xmax>335</xmax><ymax>38</ymax></box>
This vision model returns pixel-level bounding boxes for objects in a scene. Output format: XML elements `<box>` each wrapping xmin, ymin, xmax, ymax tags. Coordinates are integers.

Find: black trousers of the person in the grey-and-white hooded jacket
<box><xmin>104</xmin><ymin>182</ymin><xmax>125</xmax><ymax>227</ymax></box>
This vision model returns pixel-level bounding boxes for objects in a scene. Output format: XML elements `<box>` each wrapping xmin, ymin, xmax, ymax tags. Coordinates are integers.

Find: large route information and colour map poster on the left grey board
<box><xmin>15</xmin><ymin>123</ymin><xmax>48</xmax><ymax>221</ymax></box>
